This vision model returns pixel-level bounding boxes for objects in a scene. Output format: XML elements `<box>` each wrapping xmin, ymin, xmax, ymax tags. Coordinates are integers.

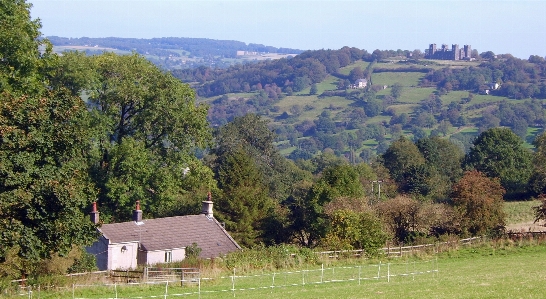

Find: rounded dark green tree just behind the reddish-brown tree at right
<box><xmin>464</xmin><ymin>128</ymin><xmax>532</xmax><ymax>196</ymax></box>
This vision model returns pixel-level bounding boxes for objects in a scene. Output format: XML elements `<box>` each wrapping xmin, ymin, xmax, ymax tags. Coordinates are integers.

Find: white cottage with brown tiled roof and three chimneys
<box><xmin>87</xmin><ymin>194</ymin><xmax>241</xmax><ymax>270</ymax></box>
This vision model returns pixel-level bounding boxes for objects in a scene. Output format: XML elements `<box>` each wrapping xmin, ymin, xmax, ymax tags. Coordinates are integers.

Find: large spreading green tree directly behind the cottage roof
<box><xmin>83</xmin><ymin>53</ymin><xmax>214</xmax><ymax>221</ymax></box>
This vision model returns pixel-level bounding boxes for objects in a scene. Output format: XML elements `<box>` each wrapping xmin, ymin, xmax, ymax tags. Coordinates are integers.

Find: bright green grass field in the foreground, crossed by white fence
<box><xmin>22</xmin><ymin>241</ymin><xmax>546</xmax><ymax>299</ymax></box>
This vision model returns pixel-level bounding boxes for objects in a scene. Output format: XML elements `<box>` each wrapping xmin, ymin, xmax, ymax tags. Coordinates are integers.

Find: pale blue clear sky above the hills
<box><xmin>27</xmin><ymin>0</ymin><xmax>546</xmax><ymax>58</ymax></box>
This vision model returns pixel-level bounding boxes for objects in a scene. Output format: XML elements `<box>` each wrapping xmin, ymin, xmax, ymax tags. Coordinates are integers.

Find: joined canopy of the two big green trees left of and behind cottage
<box><xmin>0</xmin><ymin>1</ymin><xmax>213</xmax><ymax>275</ymax></box>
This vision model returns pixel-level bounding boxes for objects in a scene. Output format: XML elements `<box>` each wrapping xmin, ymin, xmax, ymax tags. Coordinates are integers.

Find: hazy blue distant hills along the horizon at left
<box><xmin>47</xmin><ymin>36</ymin><xmax>303</xmax><ymax>69</ymax></box>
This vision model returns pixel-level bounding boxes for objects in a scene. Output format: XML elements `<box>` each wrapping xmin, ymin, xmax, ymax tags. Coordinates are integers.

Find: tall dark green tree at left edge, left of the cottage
<box><xmin>0</xmin><ymin>1</ymin><xmax>95</xmax><ymax>276</ymax></box>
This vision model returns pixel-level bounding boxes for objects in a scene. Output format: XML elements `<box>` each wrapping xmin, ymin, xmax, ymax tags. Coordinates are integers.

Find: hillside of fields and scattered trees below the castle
<box><xmin>184</xmin><ymin>47</ymin><xmax>546</xmax><ymax>162</ymax></box>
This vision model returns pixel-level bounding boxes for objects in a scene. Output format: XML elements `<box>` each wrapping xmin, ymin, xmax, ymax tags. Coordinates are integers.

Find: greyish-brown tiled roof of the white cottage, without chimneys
<box><xmin>99</xmin><ymin>214</ymin><xmax>241</xmax><ymax>258</ymax></box>
